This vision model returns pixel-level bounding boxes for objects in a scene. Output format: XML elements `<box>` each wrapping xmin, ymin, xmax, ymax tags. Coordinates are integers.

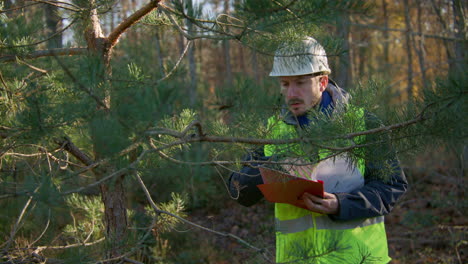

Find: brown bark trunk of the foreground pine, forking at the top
<box><xmin>81</xmin><ymin>0</ymin><xmax>159</xmax><ymax>263</ymax></box>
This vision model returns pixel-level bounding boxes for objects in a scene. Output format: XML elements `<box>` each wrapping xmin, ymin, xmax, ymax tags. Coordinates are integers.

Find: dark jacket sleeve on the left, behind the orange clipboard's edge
<box><xmin>229</xmin><ymin>148</ymin><xmax>268</xmax><ymax>206</ymax></box>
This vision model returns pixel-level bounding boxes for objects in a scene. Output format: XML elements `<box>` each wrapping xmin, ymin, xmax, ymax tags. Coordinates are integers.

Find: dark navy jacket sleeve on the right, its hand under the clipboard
<box><xmin>329</xmin><ymin>113</ymin><xmax>408</xmax><ymax>220</ymax></box>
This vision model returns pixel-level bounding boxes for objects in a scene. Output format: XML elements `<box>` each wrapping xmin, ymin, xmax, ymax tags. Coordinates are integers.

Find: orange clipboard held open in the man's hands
<box><xmin>257</xmin><ymin>168</ymin><xmax>324</xmax><ymax>209</ymax></box>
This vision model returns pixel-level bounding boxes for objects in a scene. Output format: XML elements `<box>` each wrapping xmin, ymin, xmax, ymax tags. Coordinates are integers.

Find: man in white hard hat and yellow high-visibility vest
<box><xmin>229</xmin><ymin>38</ymin><xmax>407</xmax><ymax>263</ymax></box>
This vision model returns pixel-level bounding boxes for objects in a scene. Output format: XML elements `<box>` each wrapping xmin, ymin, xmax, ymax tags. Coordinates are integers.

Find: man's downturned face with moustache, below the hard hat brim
<box><xmin>279</xmin><ymin>75</ymin><xmax>328</xmax><ymax>116</ymax></box>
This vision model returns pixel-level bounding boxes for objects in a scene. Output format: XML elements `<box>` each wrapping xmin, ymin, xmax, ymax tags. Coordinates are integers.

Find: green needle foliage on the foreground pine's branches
<box><xmin>0</xmin><ymin>0</ymin><xmax>468</xmax><ymax>263</ymax></box>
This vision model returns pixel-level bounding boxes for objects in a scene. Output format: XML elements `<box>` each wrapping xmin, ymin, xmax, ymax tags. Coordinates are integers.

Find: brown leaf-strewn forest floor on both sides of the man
<box><xmin>185</xmin><ymin>166</ymin><xmax>468</xmax><ymax>264</ymax></box>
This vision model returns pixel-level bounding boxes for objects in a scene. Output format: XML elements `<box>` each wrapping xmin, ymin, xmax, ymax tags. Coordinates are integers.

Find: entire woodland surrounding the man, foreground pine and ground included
<box><xmin>0</xmin><ymin>0</ymin><xmax>468</xmax><ymax>263</ymax></box>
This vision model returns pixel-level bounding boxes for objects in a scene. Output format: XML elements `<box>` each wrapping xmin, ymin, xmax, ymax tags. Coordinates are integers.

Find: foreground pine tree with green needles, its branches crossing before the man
<box><xmin>0</xmin><ymin>0</ymin><xmax>468</xmax><ymax>263</ymax></box>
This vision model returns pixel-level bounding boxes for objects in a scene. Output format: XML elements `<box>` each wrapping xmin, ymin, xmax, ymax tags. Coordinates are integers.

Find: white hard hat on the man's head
<box><xmin>270</xmin><ymin>37</ymin><xmax>331</xmax><ymax>76</ymax></box>
